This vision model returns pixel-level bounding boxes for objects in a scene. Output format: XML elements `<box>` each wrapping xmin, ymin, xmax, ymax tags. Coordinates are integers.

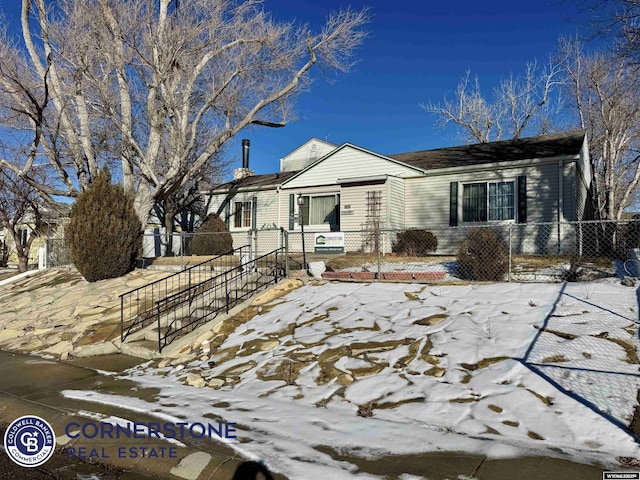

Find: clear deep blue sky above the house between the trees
<box><xmin>0</xmin><ymin>0</ymin><xmax>583</xmax><ymax>178</ymax></box>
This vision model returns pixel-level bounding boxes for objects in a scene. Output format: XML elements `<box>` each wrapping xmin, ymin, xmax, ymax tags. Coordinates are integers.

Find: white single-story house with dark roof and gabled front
<box><xmin>208</xmin><ymin>131</ymin><xmax>593</xmax><ymax>251</ymax></box>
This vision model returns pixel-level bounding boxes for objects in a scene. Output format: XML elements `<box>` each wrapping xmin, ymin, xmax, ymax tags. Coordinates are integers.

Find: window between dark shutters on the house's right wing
<box><xmin>462</xmin><ymin>181</ymin><xmax>515</xmax><ymax>222</ymax></box>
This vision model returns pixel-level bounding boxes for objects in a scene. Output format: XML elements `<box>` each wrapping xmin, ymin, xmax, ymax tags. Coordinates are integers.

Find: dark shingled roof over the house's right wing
<box><xmin>387</xmin><ymin>130</ymin><xmax>585</xmax><ymax>170</ymax></box>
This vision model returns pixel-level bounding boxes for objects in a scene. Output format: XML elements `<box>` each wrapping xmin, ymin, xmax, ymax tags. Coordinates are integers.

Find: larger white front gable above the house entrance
<box><xmin>283</xmin><ymin>144</ymin><xmax>420</xmax><ymax>188</ymax></box>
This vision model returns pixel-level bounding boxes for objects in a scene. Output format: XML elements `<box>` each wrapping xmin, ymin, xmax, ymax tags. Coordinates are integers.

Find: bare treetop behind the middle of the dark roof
<box><xmin>421</xmin><ymin>62</ymin><xmax>561</xmax><ymax>143</ymax></box>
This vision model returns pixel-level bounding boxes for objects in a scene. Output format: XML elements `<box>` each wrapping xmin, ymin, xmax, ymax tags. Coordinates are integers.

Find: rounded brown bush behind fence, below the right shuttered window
<box><xmin>457</xmin><ymin>227</ymin><xmax>509</xmax><ymax>282</ymax></box>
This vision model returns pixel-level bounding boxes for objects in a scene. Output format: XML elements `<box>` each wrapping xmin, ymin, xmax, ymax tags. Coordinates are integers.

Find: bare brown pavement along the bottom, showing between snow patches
<box><xmin>0</xmin><ymin>351</ymin><xmax>603</xmax><ymax>480</ymax></box>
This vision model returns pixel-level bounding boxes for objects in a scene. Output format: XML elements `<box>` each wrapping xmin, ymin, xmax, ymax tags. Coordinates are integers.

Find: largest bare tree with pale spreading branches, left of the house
<box><xmin>0</xmin><ymin>0</ymin><xmax>368</xmax><ymax>225</ymax></box>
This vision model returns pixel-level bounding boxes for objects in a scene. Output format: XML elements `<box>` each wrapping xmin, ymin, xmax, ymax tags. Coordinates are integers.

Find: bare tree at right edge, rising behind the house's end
<box><xmin>560</xmin><ymin>40</ymin><xmax>640</xmax><ymax>220</ymax></box>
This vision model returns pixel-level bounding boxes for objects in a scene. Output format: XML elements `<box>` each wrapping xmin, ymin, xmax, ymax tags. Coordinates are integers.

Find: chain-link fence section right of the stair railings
<box><xmin>286</xmin><ymin>220</ymin><xmax>640</xmax><ymax>282</ymax></box>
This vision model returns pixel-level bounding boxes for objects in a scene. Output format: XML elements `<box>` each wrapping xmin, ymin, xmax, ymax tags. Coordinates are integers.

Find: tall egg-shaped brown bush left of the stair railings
<box><xmin>65</xmin><ymin>167</ymin><xmax>142</xmax><ymax>282</ymax></box>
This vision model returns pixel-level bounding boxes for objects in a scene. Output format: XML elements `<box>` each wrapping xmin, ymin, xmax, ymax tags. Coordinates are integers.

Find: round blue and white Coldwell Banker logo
<box><xmin>4</xmin><ymin>415</ymin><xmax>56</xmax><ymax>467</ymax></box>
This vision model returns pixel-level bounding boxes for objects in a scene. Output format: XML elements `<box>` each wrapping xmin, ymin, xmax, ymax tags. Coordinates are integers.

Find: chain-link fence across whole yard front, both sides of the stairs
<box><xmin>40</xmin><ymin>220</ymin><xmax>640</xmax><ymax>282</ymax></box>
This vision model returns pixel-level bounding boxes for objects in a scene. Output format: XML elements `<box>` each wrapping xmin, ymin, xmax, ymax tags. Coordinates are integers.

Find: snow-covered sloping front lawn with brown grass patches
<box><xmin>65</xmin><ymin>279</ymin><xmax>640</xmax><ymax>479</ymax></box>
